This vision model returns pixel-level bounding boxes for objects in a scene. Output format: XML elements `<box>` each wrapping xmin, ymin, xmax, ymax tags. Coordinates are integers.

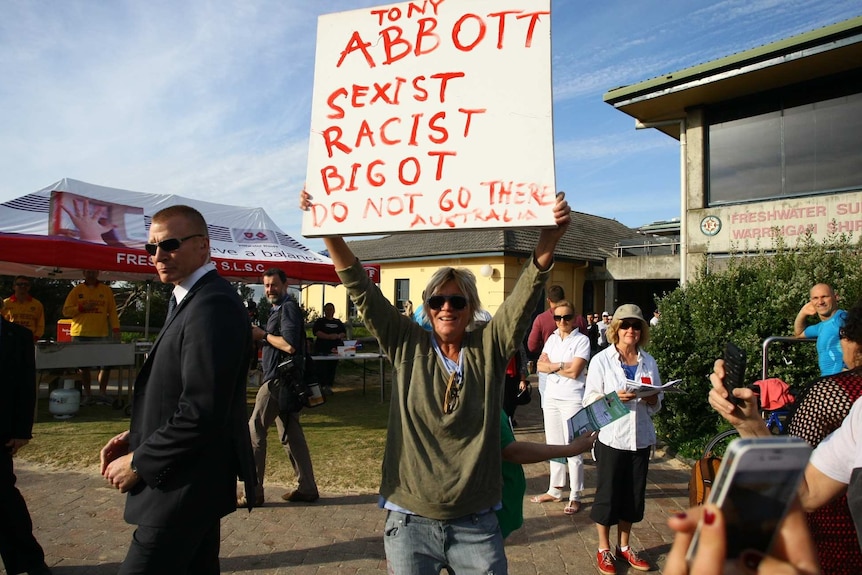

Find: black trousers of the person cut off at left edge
<box><xmin>0</xmin><ymin>452</ymin><xmax>45</xmax><ymax>575</ymax></box>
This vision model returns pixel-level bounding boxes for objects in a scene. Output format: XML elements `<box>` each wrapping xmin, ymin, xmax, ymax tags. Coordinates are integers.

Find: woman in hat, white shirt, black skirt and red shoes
<box><xmin>584</xmin><ymin>303</ymin><xmax>662</xmax><ymax>575</ymax></box>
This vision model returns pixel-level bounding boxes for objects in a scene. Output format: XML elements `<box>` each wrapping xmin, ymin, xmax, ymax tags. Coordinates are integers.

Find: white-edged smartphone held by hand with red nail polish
<box><xmin>687</xmin><ymin>436</ymin><xmax>811</xmax><ymax>569</ymax></box>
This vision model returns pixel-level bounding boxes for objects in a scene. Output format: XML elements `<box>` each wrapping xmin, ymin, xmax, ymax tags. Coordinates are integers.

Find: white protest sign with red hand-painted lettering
<box><xmin>302</xmin><ymin>0</ymin><xmax>556</xmax><ymax>237</ymax></box>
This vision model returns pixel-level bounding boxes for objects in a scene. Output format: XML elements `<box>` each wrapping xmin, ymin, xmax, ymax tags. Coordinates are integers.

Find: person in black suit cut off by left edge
<box><xmin>0</xmin><ymin>300</ymin><xmax>51</xmax><ymax>575</ymax></box>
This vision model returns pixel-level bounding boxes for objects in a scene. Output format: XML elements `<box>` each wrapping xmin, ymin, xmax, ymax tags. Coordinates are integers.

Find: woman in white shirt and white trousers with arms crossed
<box><xmin>531</xmin><ymin>300</ymin><xmax>590</xmax><ymax>515</ymax></box>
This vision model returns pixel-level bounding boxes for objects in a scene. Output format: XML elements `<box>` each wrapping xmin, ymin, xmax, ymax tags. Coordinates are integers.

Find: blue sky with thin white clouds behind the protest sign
<box><xmin>0</xmin><ymin>0</ymin><xmax>862</xmax><ymax>249</ymax></box>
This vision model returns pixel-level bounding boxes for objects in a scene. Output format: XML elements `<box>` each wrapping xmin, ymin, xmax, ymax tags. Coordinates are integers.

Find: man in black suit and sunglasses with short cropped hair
<box><xmin>101</xmin><ymin>205</ymin><xmax>256</xmax><ymax>574</ymax></box>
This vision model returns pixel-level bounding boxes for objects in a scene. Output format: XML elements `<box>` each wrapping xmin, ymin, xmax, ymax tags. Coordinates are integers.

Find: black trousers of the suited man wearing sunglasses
<box><xmin>120</xmin><ymin>519</ymin><xmax>221</xmax><ymax>575</ymax></box>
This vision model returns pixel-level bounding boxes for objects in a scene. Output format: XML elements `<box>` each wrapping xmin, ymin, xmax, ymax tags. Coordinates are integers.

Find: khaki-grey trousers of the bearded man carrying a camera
<box><xmin>248</xmin><ymin>381</ymin><xmax>317</xmax><ymax>496</ymax></box>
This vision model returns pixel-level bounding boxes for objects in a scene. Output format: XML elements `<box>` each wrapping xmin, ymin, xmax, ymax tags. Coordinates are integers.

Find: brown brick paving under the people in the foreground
<box><xmin>5</xmin><ymin>394</ymin><xmax>688</xmax><ymax>575</ymax></box>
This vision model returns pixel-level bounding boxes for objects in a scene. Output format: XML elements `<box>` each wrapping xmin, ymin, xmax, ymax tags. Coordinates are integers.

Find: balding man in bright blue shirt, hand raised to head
<box><xmin>793</xmin><ymin>284</ymin><xmax>847</xmax><ymax>376</ymax></box>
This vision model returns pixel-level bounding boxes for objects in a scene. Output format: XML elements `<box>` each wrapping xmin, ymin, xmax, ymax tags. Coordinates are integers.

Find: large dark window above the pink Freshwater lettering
<box><xmin>707</xmin><ymin>72</ymin><xmax>862</xmax><ymax>206</ymax></box>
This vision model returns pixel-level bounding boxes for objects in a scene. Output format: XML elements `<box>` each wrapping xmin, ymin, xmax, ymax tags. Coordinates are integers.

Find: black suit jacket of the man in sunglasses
<box><xmin>125</xmin><ymin>271</ymin><xmax>256</xmax><ymax>527</ymax></box>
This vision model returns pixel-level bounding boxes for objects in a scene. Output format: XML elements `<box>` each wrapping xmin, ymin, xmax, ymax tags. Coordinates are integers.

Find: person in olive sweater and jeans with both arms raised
<box><xmin>301</xmin><ymin>191</ymin><xmax>571</xmax><ymax>575</ymax></box>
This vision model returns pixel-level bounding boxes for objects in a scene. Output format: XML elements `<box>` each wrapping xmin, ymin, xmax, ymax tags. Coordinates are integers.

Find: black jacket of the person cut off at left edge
<box><xmin>0</xmin><ymin>318</ymin><xmax>36</xmax><ymax>444</ymax></box>
